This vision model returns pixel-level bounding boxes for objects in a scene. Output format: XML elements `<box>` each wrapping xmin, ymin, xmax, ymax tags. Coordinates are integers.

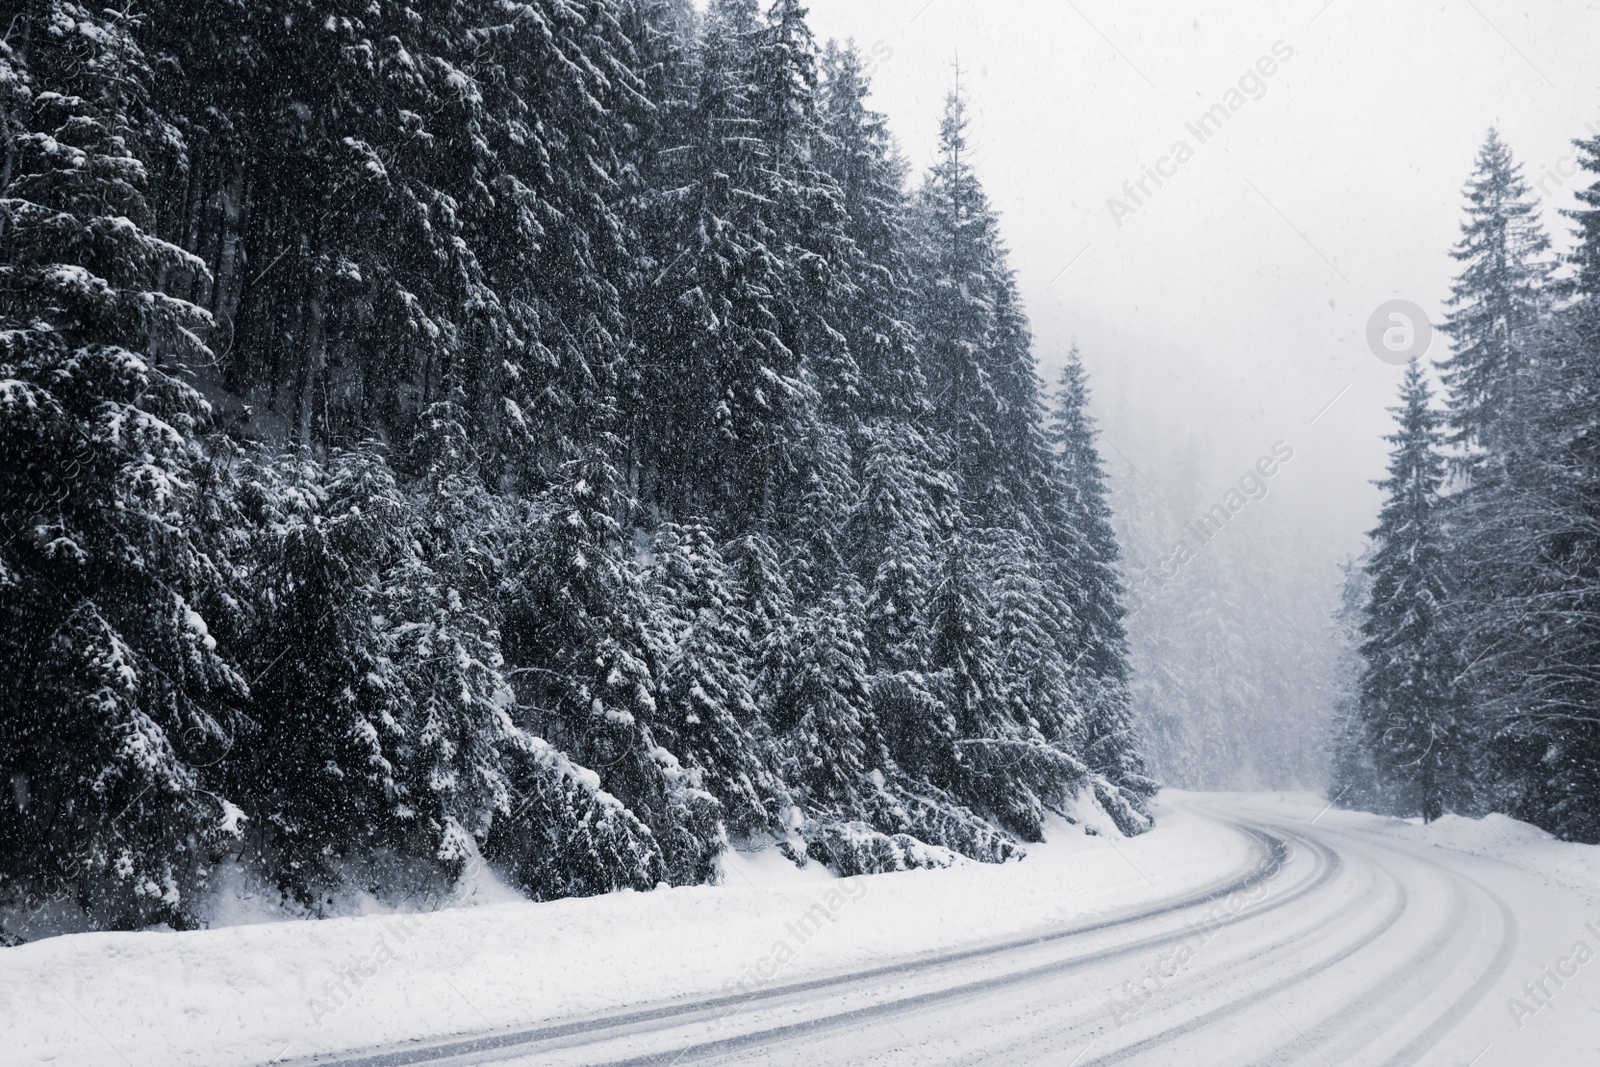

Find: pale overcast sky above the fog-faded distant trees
<box><xmin>811</xmin><ymin>0</ymin><xmax>1600</xmax><ymax>579</ymax></box>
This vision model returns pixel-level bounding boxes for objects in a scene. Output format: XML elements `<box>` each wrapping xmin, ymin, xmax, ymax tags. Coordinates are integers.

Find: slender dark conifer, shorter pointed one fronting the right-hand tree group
<box><xmin>1360</xmin><ymin>363</ymin><xmax>1466</xmax><ymax>821</ymax></box>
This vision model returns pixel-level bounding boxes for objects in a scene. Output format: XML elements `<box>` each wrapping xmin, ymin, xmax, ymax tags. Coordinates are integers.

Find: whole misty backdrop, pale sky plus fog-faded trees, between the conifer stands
<box><xmin>811</xmin><ymin>0</ymin><xmax>1600</xmax><ymax>789</ymax></box>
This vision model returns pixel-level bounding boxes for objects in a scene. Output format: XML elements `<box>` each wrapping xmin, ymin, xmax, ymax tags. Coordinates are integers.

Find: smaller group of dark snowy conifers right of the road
<box><xmin>1330</xmin><ymin>128</ymin><xmax>1600</xmax><ymax>845</ymax></box>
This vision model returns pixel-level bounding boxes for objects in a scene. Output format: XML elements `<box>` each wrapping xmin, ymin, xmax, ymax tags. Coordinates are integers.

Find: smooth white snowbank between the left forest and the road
<box><xmin>0</xmin><ymin>806</ymin><xmax>1251</xmax><ymax>1067</ymax></box>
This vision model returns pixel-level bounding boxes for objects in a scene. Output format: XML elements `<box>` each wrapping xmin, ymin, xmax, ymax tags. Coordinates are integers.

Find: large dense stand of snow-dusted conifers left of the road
<box><xmin>0</xmin><ymin>0</ymin><xmax>1155</xmax><ymax>928</ymax></box>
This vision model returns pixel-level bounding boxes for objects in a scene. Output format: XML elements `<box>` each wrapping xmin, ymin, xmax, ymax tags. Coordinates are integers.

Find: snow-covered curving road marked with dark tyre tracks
<box><xmin>291</xmin><ymin>798</ymin><xmax>1600</xmax><ymax>1067</ymax></box>
